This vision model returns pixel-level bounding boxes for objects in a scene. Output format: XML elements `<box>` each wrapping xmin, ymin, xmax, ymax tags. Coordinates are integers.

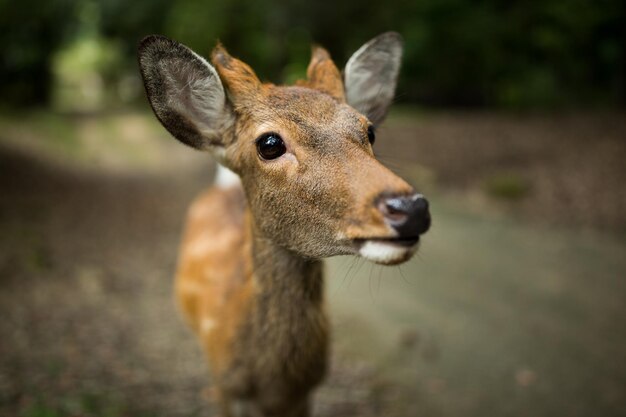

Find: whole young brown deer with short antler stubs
<box><xmin>139</xmin><ymin>33</ymin><xmax>430</xmax><ymax>417</ymax></box>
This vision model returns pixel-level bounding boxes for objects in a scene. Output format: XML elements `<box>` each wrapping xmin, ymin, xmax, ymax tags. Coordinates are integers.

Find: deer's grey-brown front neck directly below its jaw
<box><xmin>247</xmin><ymin>219</ymin><xmax>329</xmax><ymax>388</ymax></box>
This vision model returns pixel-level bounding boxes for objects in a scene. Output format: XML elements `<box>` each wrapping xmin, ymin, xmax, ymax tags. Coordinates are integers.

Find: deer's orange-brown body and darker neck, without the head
<box><xmin>176</xmin><ymin>178</ymin><xmax>328</xmax><ymax>416</ymax></box>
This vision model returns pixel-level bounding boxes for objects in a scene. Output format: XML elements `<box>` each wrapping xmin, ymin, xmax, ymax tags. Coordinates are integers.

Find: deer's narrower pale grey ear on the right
<box><xmin>344</xmin><ymin>32</ymin><xmax>402</xmax><ymax>125</ymax></box>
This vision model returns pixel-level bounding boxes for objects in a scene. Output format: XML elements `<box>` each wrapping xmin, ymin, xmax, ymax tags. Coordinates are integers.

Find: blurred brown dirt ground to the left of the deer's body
<box><xmin>0</xmin><ymin>146</ymin><xmax>210</xmax><ymax>417</ymax></box>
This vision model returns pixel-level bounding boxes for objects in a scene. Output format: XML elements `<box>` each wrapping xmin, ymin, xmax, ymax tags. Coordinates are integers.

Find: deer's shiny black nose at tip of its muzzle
<box><xmin>378</xmin><ymin>194</ymin><xmax>430</xmax><ymax>238</ymax></box>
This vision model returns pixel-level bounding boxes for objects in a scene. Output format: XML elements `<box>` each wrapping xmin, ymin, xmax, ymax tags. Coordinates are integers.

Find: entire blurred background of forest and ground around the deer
<box><xmin>0</xmin><ymin>0</ymin><xmax>626</xmax><ymax>417</ymax></box>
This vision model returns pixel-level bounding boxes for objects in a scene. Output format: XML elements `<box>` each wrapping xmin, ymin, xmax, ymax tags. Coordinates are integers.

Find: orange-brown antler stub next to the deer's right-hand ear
<box><xmin>306</xmin><ymin>46</ymin><xmax>345</xmax><ymax>101</ymax></box>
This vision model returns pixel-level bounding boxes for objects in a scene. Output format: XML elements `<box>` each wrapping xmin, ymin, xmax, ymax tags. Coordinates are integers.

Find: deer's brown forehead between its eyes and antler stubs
<box><xmin>250</xmin><ymin>86</ymin><xmax>368</xmax><ymax>145</ymax></box>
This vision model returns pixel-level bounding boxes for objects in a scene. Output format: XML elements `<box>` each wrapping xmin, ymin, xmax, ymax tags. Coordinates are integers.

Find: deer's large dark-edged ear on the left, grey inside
<box><xmin>139</xmin><ymin>35</ymin><xmax>233</xmax><ymax>150</ymax></box>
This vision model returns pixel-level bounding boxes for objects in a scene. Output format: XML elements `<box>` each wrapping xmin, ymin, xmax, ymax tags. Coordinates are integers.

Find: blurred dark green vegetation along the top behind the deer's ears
<box><xmin>0</xmin><ymin>0</ymin><xmax>626</xmax><ymax>111</ymax></box>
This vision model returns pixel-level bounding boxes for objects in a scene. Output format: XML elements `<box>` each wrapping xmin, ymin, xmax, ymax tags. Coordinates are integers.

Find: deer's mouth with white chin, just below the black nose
<box><xmin>355</xmin><ymin>236</ymin><xmax>419</xmax><ymax>265</ymax></box>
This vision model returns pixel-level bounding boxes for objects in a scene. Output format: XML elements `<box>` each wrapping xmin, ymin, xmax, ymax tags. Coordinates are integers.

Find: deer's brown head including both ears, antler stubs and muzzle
<box><xmin>139</xmin><ymin>33</ymin><xmax>430</xmax><ymax>264</ymax></box>
